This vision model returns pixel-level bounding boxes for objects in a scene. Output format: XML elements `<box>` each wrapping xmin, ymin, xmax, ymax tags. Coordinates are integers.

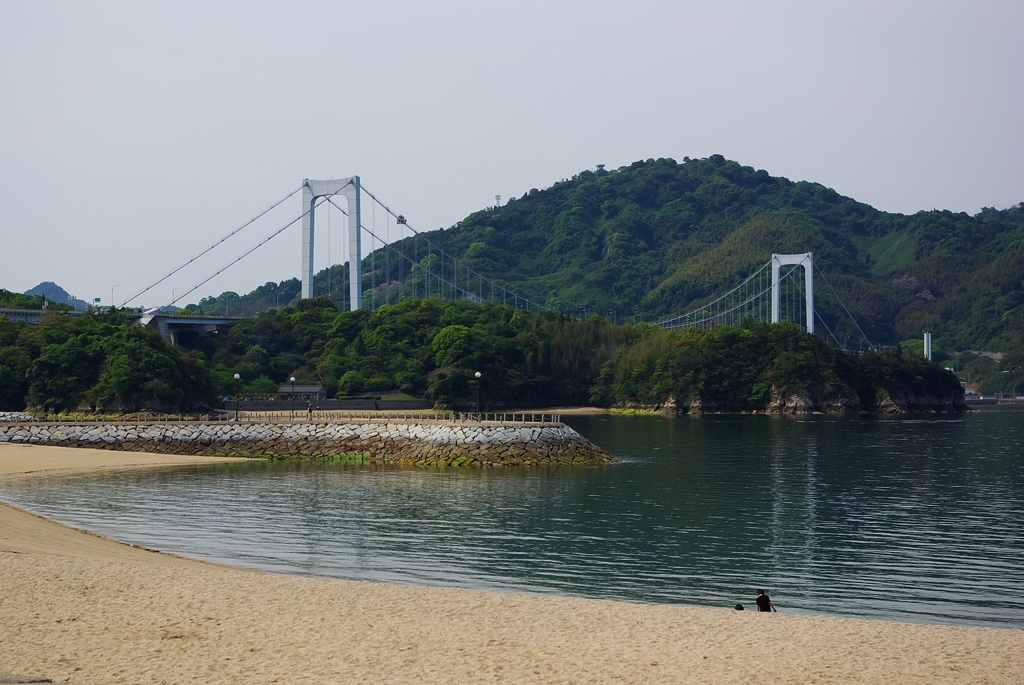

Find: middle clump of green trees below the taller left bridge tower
<box><xmin>187</xmin><ymin>298</ymin><xmax>634</xmax><ymax>408</ymax></box>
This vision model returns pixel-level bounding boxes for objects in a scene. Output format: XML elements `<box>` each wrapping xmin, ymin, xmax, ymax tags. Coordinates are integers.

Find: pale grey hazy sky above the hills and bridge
<box><xmin>0</xmin><ymin>0</ymin><xmax>1024</xmax><ymax>306</ymax></box>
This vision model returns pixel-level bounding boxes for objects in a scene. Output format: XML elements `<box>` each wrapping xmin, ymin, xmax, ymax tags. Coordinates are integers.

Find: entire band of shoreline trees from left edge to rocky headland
<box><xmin>0</xmin><ymin>298</ymin><xmax>959</xmax><ymax>412</ymax></box>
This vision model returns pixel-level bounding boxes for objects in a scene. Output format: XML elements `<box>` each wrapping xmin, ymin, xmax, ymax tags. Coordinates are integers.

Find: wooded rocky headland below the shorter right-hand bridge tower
<box><xmin>591</xmin><ymin>323</ymin><xmax>964</xmax><ymax>413</ymax></box>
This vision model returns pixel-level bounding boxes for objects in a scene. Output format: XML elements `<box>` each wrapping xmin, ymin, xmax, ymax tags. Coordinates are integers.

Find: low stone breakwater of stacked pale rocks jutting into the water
<box><xmin>0</xmin><ymin>422</ymin><xmax>618</xmax><ymax>467</ymax></box>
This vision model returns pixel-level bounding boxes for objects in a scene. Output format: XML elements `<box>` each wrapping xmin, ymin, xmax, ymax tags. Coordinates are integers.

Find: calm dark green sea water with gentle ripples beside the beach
<box><xmin>0</xmin><ymin>408</ymin><xmax>1024</xmax><ymax>628</ymax></box>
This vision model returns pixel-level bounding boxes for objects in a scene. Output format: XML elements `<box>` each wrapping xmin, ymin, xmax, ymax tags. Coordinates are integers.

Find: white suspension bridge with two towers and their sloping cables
<box><xmin>108</xmin><ymin>176</ymin><xmax>870</xmax><ymax>347</ymax></box>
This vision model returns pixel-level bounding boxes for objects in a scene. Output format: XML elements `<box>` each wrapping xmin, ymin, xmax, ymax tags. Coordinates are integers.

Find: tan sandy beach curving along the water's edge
<box><xmin>0</xmin><ymin>444</ymin><xmax>1024</xmax><ymax>685</ymax></box>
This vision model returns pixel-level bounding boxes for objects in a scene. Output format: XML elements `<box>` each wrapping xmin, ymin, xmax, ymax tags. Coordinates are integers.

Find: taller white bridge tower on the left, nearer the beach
<box><xmin>301</xmin><ymin>176</ymin><xmax>362</xmax><ymax>311</ymax></box>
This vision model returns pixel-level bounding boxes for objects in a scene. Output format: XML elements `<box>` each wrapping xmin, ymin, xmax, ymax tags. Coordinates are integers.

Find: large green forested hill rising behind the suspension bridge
<box><xmin>201</xmin><ymin>155</ymin><xmax>1024</xmax><ymax>389</ymax></box>
